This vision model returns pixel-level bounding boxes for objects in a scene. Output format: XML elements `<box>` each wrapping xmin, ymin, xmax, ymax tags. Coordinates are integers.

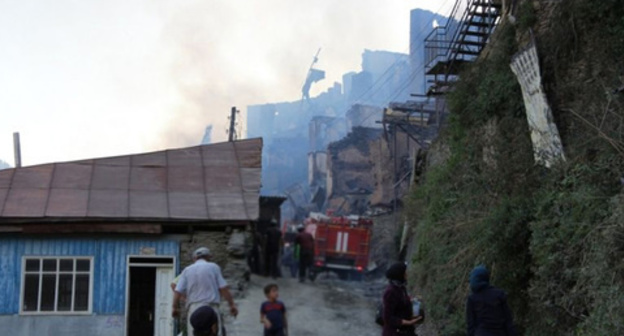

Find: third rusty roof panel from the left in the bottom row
<box><xmin>87</xmin><ymin>189</ymin><xmax>128</xmax><ymax>218</ymax></box>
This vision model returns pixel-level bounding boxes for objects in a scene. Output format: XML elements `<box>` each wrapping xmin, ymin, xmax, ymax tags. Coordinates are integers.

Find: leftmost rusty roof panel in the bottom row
<box><xmin>2</xmin><ymin>188</ymin><xmax>48</xmax><ymax>217</ymax></box>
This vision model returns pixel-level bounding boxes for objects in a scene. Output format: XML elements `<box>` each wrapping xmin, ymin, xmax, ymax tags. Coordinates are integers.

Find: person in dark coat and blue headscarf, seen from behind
<box><xmin>466</xmin><ymin>266</ymin><xmax>517</xmax><ymax>336</ymax></box>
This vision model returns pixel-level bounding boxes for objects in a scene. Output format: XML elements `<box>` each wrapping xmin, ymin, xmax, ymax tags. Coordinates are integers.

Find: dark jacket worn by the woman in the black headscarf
<box><xmin>382</xmin><ymin>283</ymin><xmax>414</xmax><ymax>336</ymax></box>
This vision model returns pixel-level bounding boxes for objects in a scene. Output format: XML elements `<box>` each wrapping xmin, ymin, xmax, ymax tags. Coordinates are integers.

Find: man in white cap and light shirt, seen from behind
<box><xmin>172</xmin><ymin>247</ymin><xmax>238</xmax><ymax>335</ymax></box>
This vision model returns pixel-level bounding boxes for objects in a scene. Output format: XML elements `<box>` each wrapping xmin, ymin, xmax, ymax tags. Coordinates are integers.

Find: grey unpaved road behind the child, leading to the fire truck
<box><xmin>226</xmin><ymin>276</ymin><xmax>381</xmax><ymax>336</ymax></box>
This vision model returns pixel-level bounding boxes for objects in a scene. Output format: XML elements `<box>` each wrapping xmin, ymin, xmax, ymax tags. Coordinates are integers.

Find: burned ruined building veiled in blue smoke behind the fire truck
<box><xmin>247</xmin><ymin>50</ymin><xmax>411</xmax><ymax>223</ymax></box>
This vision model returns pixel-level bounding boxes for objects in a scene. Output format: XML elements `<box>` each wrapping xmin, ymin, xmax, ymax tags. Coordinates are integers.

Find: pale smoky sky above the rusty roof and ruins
<box><xmin>0</xmin><ymin>0</ymin><xmax>453</xmax><ymax>165</ymax></box>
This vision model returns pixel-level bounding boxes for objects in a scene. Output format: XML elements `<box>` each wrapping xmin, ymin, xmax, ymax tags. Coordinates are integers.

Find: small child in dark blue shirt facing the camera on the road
<box><xmin>260</xmin><ymin>284</ymin><xmax>288</xmax><ymax>336</ymax></box>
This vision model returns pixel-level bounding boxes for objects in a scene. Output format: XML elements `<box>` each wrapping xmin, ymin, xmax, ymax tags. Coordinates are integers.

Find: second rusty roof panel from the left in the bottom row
<box><xmin>45</xmin><ymin>189</ymin><xmax>89</xmax><ymax>217</ymax></box>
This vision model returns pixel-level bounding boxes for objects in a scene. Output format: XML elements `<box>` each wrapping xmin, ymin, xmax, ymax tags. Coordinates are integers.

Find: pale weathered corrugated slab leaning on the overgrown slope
<box><xmin>511</xmin><ymin>38</ymin><xmax>565</xmax><ymax>168</ymax></box>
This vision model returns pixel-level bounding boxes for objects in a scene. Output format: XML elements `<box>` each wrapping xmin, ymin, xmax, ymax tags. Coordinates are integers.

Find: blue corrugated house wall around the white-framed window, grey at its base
<box><xmin>0</xmin><ymin>237</ymin><xmax>180</xmax><ymax>336</ymax></box>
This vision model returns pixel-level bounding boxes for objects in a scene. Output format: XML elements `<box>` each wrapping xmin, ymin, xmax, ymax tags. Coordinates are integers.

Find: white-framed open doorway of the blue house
<box><xmin>126</xmin><ymin>256</ymin><xmax>174</xmax><ymax>336</ymax></box>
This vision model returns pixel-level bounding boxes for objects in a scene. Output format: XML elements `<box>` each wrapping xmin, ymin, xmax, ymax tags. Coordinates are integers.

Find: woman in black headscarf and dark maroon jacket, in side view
<box><xmin>382</xmin><ymin>262</ymin><xmax>424</xmax><ymax>336</ymax></box>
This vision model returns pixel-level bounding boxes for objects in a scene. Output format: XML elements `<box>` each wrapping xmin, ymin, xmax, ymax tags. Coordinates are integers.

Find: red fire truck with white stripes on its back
<box><xmin>305</xmin><ymin>213</ymin><xmax>373</xmax><ymax>280</ymax></box>
